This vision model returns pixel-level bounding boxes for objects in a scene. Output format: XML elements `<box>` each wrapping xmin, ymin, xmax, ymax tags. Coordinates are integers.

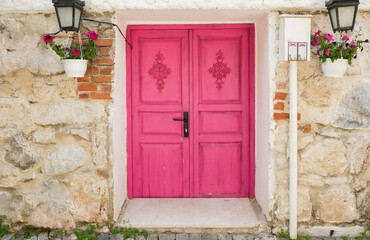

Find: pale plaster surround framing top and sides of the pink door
<box><xmin>113</xmin><ymin>10</ymin><xmax>276</xmax><ymax>220</ymax></box>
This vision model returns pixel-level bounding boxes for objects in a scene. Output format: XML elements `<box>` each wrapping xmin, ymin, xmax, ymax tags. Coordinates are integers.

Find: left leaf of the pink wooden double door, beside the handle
<box><xmin>132</xmin><ymin>30</ymin><xmax>189</xmax><ymax>197</ymax></box>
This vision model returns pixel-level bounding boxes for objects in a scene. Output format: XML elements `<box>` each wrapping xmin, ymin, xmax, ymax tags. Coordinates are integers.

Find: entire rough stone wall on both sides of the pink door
<box><xmin>0</xmin><ymin>5</ymin><xmax>370</xmax><ymax>234</ymax></box>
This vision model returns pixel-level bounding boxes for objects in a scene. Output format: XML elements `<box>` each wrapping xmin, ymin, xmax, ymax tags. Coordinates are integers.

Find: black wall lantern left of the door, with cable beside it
<box><xmin>53</xmin><ymin>0</ymin><xmax>85</xmax><ymax>32</ymax></box>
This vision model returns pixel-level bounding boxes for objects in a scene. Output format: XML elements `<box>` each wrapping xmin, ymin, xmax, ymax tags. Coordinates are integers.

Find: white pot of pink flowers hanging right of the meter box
<box><xmin>312</xmin><ymin>30</ymin><xmax>368</xmax><ymax>77</ymax></box>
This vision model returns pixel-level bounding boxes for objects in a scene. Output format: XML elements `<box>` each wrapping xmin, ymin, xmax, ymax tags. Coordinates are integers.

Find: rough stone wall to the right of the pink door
<box><xmin>272</xmin><ymin>12</ymin><xmax>370</xmax><ymax>234</ymax></box>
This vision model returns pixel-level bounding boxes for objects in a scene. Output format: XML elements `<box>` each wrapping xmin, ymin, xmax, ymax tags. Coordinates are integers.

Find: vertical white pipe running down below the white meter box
<box><xmin>289</xmin><ymin>61</ymin><xmax>298</xmax><ymax>239</ymax></box>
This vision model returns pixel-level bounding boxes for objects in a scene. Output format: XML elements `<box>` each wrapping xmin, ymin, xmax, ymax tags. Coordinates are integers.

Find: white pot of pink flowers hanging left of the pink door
<box><xmin>44</xmin><ymin>31</ymin><xmax>98</xmax><ymax>77</ymax></box>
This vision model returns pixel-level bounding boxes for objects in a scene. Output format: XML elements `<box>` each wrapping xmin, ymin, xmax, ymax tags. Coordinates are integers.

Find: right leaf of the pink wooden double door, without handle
<box><xmin>192</xmin><ymin>29</ymin><xmax>249</xmax><ymax>197</ymax></box>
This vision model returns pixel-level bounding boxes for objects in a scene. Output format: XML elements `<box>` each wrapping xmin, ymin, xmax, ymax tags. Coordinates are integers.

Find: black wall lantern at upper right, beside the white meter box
<box><xmin>325</xmin><ymin>0</ymin><xmax>360</xmax><ymax>32</ymax></box>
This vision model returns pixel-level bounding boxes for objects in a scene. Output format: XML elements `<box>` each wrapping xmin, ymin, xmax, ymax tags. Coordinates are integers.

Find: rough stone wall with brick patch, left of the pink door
<box><xmin>0</xmin><ymin>14</ymin><xmax>115</xmax><ymax>229</ymax></box>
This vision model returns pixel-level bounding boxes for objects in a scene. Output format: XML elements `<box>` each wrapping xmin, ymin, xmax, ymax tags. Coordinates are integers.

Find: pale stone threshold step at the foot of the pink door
<box><xmin>118</xmin><ymin>198</ymin><xmax>269</xmax><ymax>233</ymax></box>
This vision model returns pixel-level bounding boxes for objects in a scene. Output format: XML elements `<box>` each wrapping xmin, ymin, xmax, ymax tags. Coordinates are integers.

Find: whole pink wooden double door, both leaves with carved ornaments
<box><xmin>127</xmin><ymin>24</ymin><xmax>254</xmax><ymax>198</ymax></box>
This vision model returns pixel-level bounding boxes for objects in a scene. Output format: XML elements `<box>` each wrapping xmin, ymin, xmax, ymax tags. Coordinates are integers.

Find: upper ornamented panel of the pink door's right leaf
<box><xmin>198</xmin><ymin>37</ymin><xmax>241</xmax><ymax>103</ymax></box>
